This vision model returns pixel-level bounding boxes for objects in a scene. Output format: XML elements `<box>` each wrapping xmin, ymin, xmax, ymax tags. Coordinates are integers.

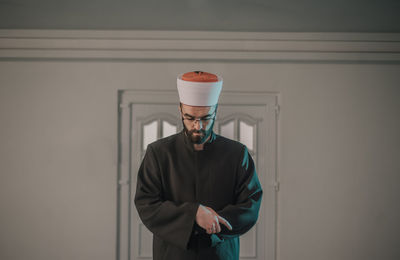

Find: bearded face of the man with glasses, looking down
<box><xmin>180</xmin><ymin>104</ymin><xmax>217</xmax><ymax>144</ymax></box>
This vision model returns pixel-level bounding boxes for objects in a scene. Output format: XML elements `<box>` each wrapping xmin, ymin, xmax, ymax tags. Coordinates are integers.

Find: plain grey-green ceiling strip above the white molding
<box><xmin>0</xmin><ymin>0</ymin><xmax>400</xmax><ymax>33</ymax></box>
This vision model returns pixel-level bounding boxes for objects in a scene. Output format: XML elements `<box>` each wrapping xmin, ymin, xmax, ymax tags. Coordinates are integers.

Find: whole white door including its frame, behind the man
<box><xmin>117</xmin><ymin>91</ymin><xmax>277</xmax><ymax>260</ymax></box>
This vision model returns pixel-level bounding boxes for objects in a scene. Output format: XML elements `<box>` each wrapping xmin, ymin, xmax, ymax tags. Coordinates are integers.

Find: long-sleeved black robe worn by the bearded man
<box><xmin>135</xmin><ymin>131</ymin><xmax>262</xmax><ymax>260</ymax></box>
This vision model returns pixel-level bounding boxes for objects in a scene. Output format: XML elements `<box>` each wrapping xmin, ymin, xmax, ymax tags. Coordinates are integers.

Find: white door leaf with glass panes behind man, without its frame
<box><xmin>131</xmin><ymin>104</ymin><xmax>265</xmax><ymax>259</ymax></box>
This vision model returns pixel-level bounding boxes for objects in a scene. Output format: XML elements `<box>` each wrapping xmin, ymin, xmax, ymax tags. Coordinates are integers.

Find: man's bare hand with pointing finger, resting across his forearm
<box><xmin>196</xmin><ymin>204</ymin><xmax>232</xmax><ymax>234</ymax></box>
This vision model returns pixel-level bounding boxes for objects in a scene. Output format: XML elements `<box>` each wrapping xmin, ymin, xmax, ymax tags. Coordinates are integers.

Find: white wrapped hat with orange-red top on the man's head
<box><xmin>177</xmin><ymin>71</ymin><xmax>222</xmax><ymax>106</ymax></box>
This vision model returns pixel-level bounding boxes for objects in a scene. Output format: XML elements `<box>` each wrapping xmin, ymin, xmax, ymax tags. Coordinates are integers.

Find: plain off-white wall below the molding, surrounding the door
<box><xmin>0</xmin><ymin>32</ymin><xmax>400</xmax><ymax>260</ymax></box>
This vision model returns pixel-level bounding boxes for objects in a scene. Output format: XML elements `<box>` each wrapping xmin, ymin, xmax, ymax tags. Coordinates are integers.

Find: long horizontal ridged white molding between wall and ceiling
<box><xmin>0</xmin><ymin>30</ymin><xmax>400</xmax><ymax>63</ymax></box>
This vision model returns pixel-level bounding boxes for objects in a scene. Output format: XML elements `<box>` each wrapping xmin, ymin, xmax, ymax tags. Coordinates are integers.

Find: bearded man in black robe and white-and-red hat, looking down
<box><xmin>135</xmin><ymin>71</ymin><xmax>262</xmax><ymax>260</ymax></box>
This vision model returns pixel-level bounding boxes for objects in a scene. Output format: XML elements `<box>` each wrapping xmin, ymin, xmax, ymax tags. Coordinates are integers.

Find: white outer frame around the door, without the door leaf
<box><xmin>116</xmin><ymin>90</ymin><xmax>280</xmax><ymax>260</ymax></box>
